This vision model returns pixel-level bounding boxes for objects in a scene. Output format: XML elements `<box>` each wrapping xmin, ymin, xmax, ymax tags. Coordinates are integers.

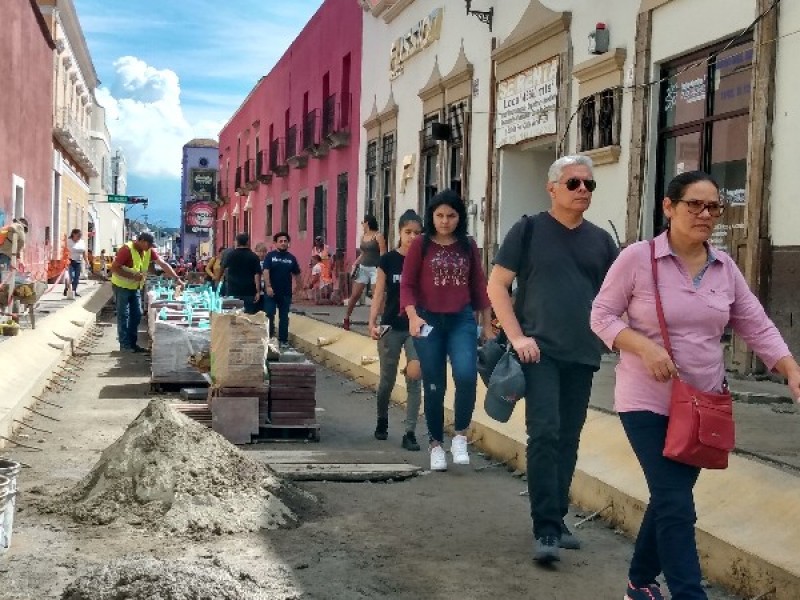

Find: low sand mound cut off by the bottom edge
<box><xmin>61</xmin><ymin>558</ymin><xmax>276</xmax><ymax>600</ymax></box>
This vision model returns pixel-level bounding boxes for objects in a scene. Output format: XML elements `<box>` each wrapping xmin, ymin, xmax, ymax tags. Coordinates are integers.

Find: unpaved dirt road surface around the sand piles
<box><xmin>0</xmin><ymin>312</ymin><xmax>731</xmax><ymax>600</ymax></box>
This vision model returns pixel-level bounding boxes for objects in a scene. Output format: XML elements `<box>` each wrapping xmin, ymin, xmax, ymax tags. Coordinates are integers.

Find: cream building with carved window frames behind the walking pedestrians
<box><xmin>359</xmin><ymin>0</ymin><xmax>800</xmax><ymax>371</ymax></box>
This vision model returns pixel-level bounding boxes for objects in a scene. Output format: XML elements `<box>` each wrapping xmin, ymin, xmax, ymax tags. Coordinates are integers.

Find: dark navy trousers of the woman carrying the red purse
<box><xmin>619</xmin><ymin>411</ymin><xmax>708</xmax><ymax>600</ymax></box>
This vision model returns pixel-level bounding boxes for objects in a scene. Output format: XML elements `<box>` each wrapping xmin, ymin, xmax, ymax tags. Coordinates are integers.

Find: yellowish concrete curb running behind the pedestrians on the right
<box><xmin>290</xmin><ymin>315</ymin><xmax>800</xmax><ymax>600</ymax></box>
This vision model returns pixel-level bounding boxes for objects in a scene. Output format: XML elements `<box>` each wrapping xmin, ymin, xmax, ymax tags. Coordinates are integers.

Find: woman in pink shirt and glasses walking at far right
<box><xmin>591</xmin><ymin>171</ymin><xmax>800</xmax><ymax>600</ymax></box>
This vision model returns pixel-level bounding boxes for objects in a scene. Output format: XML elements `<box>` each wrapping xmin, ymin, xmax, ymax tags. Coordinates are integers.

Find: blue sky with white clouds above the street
<box><xmin>74</xmin><ymin>0</ymin><xmax>322</xmax><ymax>226</ymax></box>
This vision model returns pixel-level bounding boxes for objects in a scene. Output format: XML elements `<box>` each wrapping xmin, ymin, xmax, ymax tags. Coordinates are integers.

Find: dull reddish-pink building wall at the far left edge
<box><xmin>0</xmin><ymin>0</ymin><xmax>55</xmax><ymax>276</ymax></box>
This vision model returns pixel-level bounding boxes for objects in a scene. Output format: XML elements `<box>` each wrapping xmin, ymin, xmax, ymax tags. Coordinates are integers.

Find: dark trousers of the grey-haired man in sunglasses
<box><xmin>522</xmin><ymin>355</ymin><xmax>595</xmax><ymax>538</ymax></box>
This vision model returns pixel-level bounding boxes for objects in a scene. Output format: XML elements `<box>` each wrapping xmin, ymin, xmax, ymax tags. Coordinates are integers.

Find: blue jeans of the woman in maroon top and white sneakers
<box><xmin>414</xmin><ymin>306</ymin><xmax>478</xmax><ymax>443</ymax></box>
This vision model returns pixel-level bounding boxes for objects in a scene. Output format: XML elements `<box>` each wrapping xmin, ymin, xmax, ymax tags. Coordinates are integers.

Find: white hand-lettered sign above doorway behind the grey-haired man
<box><xmin>495</xmin><ymin>58</ymin><xmax>558</xmax><ymax>148</ymax></box>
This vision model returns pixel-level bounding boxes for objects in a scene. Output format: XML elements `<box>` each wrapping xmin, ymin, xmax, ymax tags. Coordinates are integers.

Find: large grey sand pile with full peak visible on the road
<box><xmin>43</xmin><ymin>400</ymin><xmax>314</xmax><ymax>536</ymax></box>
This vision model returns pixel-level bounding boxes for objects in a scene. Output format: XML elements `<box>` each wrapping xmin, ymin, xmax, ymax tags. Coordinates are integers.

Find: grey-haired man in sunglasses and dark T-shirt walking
<box><xmin>488</xmin><ymin>156</ymin><xmax>618</xmax><ymax>564</ymax></box>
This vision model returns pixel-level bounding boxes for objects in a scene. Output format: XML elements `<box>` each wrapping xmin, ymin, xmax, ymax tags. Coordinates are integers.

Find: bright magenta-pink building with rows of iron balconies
<box><xmin>215</xmin><ymin>0</ymin><xmax>362</xmax><ymax>268</ymax></box>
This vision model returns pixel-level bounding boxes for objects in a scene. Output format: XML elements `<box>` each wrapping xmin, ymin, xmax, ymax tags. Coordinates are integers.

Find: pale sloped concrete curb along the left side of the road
<box><xmin>0</xmin><ymin>284</ymin><xmax>111</xmax><ymax>448</ymax></box>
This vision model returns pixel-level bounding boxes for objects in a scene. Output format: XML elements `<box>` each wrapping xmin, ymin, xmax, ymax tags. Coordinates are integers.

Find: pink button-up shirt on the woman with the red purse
<box><xmin>591</xmin><ymin>233</ymin><xmax>791</xmax><ymax>415</ymax></box>
